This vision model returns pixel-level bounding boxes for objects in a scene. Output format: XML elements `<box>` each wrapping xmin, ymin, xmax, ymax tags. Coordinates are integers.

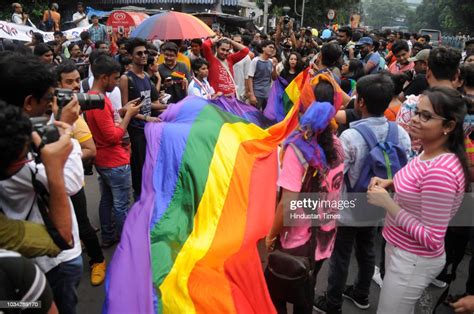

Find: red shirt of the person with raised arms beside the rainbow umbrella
<box><xmin>202</xmin><ymin>39</ymin><xmax>249</xmax><ymax>95</ymax></box>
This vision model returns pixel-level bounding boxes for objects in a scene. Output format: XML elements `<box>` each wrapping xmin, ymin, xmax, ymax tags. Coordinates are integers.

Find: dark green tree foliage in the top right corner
<box><xmin>411</xmin><ymin>0</ymin><xmax>474</xmax><ymax>34</ymax></box>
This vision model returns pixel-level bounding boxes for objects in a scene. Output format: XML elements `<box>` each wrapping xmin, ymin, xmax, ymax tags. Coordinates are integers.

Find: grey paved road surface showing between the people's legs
<box><xmin>77</xmin><ymin>174</ymin><xmax>469</xmax><ymax>314</ymax></box>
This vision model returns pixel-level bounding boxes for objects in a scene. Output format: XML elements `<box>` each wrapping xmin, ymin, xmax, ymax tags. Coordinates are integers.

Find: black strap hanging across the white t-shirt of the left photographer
<box><xmin>28</xmin><ymin>169</ymin><xmax>73</xmax><ymax>250</ymax></box>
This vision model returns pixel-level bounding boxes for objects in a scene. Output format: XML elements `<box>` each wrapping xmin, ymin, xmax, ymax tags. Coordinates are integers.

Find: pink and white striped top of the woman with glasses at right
<box><xmin>383</xmin><ymin>153</ymin><xmax>465</xmax><ymax>257</ymax></box>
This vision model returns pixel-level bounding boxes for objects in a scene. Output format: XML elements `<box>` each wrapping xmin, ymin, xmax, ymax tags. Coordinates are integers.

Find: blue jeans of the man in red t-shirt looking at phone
<box><xmin>96</xmin><ymin>165</ymin><xmax>131</xmax><ymax>242</ymax></box>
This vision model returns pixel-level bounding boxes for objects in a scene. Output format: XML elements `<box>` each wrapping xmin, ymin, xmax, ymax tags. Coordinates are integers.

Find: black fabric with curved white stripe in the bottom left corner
<box><xmin>0</xmin><ymin>249</ymin><xmax>53</xmax><ymax>314</ymax></box>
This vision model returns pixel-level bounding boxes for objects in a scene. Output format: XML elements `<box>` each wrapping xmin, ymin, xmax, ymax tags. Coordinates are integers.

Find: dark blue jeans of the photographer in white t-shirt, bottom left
<box><xmin>46</xmin><ymin>255</ymin><xmax>82</xmax><ymax>314</ymax></box>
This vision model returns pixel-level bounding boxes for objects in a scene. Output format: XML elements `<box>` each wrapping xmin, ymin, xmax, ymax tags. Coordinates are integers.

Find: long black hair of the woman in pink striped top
<box><xmin>423</xmin><ymin>87</ymin><xmax>471</xmax><ymax>192</ymax></box>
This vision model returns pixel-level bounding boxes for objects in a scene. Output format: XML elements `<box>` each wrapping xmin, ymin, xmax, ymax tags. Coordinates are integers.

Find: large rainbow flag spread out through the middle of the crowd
<box><xmin>103</xmin><ymin>97</ymin><xmax>298</xmax><ymax>314</ymax></box>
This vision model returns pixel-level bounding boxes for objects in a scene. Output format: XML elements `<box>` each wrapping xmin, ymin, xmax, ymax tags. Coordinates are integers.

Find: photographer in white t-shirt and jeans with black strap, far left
<box><xmin>0</xmin><ymin>54</ymin><xmax>84</xmax><ymax>313</ymax></box>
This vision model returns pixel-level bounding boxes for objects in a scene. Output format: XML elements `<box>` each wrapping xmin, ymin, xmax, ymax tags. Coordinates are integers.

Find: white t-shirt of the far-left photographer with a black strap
<box><xmin>0</xmin><ymin>139</ymin><xmax>84</xmax><ymax>273</ymax></box>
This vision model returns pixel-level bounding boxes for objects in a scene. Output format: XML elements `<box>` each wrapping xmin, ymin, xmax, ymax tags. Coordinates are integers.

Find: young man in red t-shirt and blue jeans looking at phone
<box><xmin>85</xmin><ymin>55</ymin><xmax>145</xmax><ymax>248</ymax></box>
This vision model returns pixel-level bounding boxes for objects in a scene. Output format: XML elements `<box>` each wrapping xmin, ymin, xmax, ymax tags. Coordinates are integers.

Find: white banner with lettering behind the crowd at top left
<box><xmin>0</xmin><ymin>21</ymin><xmax>87</xmax><ymax>42</ymax></box>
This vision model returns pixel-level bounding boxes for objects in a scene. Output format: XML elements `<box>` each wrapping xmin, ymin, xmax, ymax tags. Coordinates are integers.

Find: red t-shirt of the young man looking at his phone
<box><xmin>85</xmin><ymin>91</ymin><xmax>130</xmax><ymax>168</ymax></box>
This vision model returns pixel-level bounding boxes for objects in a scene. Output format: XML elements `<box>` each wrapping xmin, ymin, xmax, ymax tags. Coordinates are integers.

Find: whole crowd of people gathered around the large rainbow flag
<box><xmin>0</xmin><ymin>3</ymin><xmax>474</xmax><ymax>313</ymax></box>
